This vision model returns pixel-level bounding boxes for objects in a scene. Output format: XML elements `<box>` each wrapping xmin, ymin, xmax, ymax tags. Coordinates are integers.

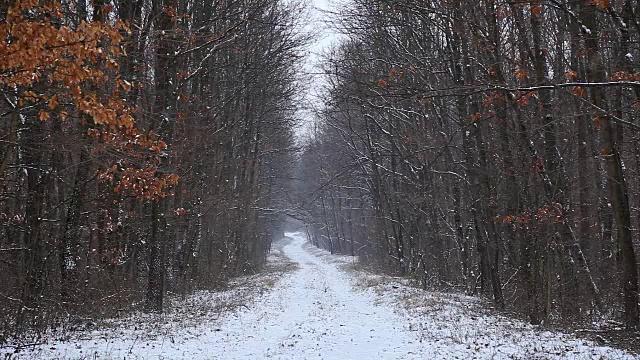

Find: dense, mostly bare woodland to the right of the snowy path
<box><xmin>299</xmin><ymin>0</ymin><xmax>640</xmax><ymax>327</ymax></box>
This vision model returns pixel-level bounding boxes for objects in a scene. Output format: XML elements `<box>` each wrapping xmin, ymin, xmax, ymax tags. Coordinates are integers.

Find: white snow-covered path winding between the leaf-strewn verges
<box><xmin>210</xmin><ymin>233</ymin><xmax>425</xmax><ymax>359</ymax></box>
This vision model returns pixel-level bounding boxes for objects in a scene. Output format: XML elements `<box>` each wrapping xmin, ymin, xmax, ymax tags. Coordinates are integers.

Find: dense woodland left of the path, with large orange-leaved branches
<box><xmin>0</xmin><ymin>0</ymin><xmax>306</xmax><ymax>343</ymax></box>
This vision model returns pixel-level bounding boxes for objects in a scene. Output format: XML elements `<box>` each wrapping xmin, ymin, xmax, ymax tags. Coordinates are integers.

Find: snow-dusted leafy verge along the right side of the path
<box><xmin>308</xmin><ymin>243</ymin><xmax>640</xmax><ymax>360</ymax></box>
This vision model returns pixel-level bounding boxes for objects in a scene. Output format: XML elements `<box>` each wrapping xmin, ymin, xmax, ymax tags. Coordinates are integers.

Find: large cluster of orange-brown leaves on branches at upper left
<box><xmin>0</xmin><ymin>0</ymin><xmax>178</xmax><ymax>199</ymax></box>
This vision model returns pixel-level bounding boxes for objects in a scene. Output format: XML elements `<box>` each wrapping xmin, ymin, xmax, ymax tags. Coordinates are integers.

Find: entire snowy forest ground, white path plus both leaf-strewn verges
<box><xmin>7</xmin><ymin>233</ymin><xmax>638</xmax><ymax>360</ymax></box>
